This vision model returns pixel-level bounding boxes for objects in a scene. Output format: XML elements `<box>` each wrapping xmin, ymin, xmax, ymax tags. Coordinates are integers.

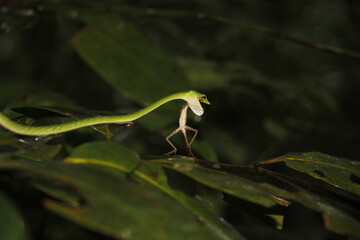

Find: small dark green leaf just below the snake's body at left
<box><xmin>14</xmin><ymin>144</ymin><xmax>62</xmax><ymax>161</ymax></box>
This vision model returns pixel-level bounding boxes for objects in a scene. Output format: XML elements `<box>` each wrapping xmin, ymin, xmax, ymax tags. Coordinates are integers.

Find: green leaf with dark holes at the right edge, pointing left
<box><xmin>280</xmin><ymin>152</ymin><xmax>360</xmax><ymax>195</ymax></box>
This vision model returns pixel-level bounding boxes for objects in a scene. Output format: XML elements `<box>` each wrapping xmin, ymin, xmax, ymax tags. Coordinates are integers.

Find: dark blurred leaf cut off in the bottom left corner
<box><xmin>0</xmin><ymin>191</ymin><xmax>29</xmax><ymax>240</ymax></box>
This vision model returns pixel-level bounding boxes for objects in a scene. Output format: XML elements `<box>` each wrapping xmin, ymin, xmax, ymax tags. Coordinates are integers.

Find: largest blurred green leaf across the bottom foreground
<box><xmin>0</xmin><ymin>161</ymin><xmax>231</xmax><ymax>240</ymax></box>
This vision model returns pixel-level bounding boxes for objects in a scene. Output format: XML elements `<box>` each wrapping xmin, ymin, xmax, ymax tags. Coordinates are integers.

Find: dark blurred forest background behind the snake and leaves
<box><xmin>0</xmin><ymin>0</ymin><xmax>360</xmax><ymax>169</ymax></box>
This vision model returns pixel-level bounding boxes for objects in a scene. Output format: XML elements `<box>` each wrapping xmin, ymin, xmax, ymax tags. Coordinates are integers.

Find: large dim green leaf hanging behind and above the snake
<box><xmin>72</xmin><ymin>14</ymin><xmax>189</xmax><ymax>104</ymax></box>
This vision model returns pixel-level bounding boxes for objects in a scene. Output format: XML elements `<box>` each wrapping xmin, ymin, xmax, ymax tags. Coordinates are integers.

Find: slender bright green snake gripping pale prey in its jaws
<box><xmin>0</xmin><ymin>91</ymin><xmax>210</xmax><ymax>136</ymax></box>
